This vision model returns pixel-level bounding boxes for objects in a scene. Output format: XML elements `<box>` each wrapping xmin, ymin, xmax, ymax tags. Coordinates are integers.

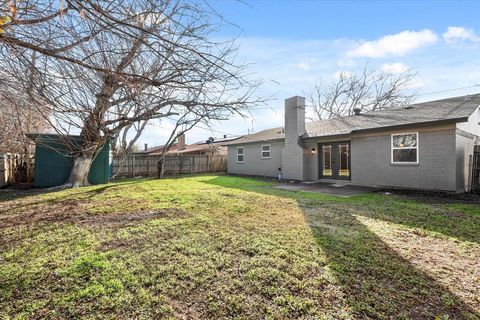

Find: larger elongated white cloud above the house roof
<box><xmin>347</xmin><ymin>29</ymin><xmax>438</xmax><ymax>58</ymax></box>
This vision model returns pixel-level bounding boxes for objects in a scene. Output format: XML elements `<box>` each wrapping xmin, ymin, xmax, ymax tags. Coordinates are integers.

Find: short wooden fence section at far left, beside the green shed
<box><xmin>0</xmin><ymin>153</ymin><xmax>35</xmax><ymax>186</ymax></box>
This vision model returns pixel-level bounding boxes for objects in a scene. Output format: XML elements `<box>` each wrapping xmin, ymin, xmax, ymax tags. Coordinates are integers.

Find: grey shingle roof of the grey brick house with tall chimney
<box><xmin>226</xmin><ymin>94</ymin><xmax>480</xmax><ymax>144</ymax></box>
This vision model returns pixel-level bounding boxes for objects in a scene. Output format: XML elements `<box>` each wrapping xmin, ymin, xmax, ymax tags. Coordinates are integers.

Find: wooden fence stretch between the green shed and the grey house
<box><xmin>112</xmin><ymin>154</ymin><xmax>227</xmax><ymax>177</ymax></box>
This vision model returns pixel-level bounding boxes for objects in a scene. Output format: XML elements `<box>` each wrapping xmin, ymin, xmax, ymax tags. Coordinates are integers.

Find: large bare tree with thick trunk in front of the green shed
<box><xmin>0</xmin><ymin>0</ymin><xmax>261</xmax><ymax>186</ymax></box>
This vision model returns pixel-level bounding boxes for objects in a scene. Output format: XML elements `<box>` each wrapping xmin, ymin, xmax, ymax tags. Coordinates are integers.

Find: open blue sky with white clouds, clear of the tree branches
<box><xmin>138</xmin><ymin>0</ymin><xmax>480</xmax><ymax>146</ymax></box>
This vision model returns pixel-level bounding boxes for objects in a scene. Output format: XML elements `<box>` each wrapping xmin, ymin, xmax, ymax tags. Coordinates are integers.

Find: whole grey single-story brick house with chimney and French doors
<box><xmin>227</xmin><ymin>94</ymin><xmax>480</xmax><ymax>192</ymax></box>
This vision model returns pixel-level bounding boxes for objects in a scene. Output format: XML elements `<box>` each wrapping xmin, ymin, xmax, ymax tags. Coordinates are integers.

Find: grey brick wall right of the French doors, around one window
<box><xmin>351</xmin><ymin>124</ymin><xmax>457</xmax><ymax>191</ymax></box>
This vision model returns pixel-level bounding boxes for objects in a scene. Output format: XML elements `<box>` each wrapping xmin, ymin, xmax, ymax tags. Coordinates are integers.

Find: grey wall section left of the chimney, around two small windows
<box><xmin>227</xmin><ymin>141</ymin><xmax>285</xmax><ymax>177</ymax></box>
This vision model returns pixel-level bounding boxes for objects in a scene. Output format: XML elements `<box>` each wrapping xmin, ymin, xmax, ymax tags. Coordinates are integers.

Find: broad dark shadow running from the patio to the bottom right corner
<box><xmin>206</xmin><ymin>177</ymin><xmax>480</xmax><ymax>319</ymax></box>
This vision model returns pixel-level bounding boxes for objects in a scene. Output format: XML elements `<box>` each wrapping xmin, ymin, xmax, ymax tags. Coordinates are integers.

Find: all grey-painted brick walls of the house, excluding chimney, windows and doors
<box><xmin>228</xmin><ymin>124</ymin><xmax>476</xmax><ymax>192</ymax></box>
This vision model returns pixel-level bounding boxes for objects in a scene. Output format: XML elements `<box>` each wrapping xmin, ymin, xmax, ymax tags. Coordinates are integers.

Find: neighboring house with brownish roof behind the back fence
<box><xmin>136</xmin><ymin>134</ymin><xmax>240</xmax><ymax>156</ymax></box>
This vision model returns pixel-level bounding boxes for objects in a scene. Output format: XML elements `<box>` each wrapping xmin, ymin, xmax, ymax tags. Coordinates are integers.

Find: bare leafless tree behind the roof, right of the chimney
<box><xmin>308</xmin><ymin>66</ymin><xmax>415</xmax><ymax>120</ymax></box>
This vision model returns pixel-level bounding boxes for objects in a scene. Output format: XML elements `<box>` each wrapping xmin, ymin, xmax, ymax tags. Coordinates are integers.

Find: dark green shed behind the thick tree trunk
<box><xmin>28</xmin><ymin>134</ymin><xmax>110</xmax><ymax>187</ymax></box>
